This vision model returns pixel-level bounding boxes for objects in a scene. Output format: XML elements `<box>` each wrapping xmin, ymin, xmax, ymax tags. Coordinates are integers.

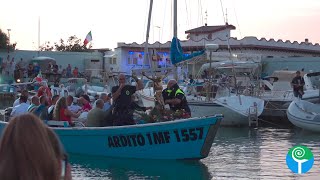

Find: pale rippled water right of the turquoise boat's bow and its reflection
<box><xmin>201</xmin><ymin>127</ymin><xmax>320</xmax><ymax>179</ymax></box>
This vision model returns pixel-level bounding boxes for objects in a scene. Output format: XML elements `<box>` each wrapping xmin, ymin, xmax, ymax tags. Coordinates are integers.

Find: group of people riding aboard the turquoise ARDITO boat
<box><xmin>11</xmin><ymin>71</ymin><xmax>191</xmax><ymax>127</ymax></box>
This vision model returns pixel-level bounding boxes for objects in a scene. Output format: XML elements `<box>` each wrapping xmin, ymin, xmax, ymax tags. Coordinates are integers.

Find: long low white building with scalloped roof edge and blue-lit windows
<box><xmin>115</xmin><ymin>24</ymin><xmax>320</xmax><ymax>73</ymax></box>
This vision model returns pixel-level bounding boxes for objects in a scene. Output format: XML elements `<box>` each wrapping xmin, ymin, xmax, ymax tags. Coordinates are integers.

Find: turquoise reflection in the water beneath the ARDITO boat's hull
<box><xmin>70</xmin><ymin>155</ymin><xmax>211</xmax><ymax>179</ymax></box>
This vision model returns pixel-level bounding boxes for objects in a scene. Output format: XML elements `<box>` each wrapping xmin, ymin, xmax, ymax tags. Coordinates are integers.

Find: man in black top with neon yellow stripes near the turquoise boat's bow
<box><xmin>164</xmin><ymin>79</ymin><xmax>191</xmax><ymax>118</ymax></box>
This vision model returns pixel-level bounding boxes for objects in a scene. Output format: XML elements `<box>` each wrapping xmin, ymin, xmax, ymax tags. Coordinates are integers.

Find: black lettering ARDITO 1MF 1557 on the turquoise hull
<box><xmin>108</xmin><ymin>127</ymin><xmax>203</xmax><ymax>148</ymax></box>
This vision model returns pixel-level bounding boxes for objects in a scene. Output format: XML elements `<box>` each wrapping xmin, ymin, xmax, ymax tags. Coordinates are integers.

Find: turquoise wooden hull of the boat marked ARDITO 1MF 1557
<box><xmin>0</xmin><ymin>115</ymin><xmax>223</xmax><ymax>159</ymax></box>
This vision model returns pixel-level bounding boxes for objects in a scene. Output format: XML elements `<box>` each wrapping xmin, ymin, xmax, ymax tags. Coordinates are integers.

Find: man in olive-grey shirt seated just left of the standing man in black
<box><xmin>85</xmin><ymin>99</ymin><xmax>107</xmax><ymax>127</ymax></box>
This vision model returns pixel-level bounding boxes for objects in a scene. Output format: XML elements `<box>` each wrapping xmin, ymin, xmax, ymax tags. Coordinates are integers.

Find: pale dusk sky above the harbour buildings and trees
<box><xmin>0</xmin><ymin>0</ymin><xmax>320</xmax><ymax>50</ymax></box>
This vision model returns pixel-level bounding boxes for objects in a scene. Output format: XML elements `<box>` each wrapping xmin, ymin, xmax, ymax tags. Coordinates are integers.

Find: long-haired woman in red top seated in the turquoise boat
<box><xmin>53</xmin><ymin>97</ymin><xmax>81</xmax><ymax>125</ymax></box>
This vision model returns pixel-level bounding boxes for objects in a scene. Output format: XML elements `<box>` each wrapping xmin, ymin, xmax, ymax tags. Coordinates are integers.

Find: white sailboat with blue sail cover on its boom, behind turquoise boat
<box><xmin>138</xmin><ymin>2</ymin><xmax>264</xmax><ymax>126</ymax></box>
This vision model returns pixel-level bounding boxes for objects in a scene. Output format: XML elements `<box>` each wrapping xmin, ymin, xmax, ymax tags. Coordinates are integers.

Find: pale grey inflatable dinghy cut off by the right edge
<box><xmin>287</xmin><ymin>100</ymin><xmax>320</xmax><ymax>132</ymax></box>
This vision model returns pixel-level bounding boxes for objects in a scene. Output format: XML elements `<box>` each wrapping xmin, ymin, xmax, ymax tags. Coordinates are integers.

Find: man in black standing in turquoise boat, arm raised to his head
<box><xmin>111</xmin><ymin>74</ymin><xmax>143</xmax><ymax>126</ymax></box>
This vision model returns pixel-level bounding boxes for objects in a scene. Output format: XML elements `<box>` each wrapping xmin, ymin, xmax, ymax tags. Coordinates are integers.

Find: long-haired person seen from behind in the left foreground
<box><xmin>0</xmin><ymin>113</ymin><xmax>66</xmax><ymax>180</ymax></box>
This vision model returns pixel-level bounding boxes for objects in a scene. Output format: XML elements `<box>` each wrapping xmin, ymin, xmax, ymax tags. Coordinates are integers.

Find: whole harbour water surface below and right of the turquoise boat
<box><xmin>70</xmin><ymin>127</ymin><xmax>320</xmax><ymax>179</ymax></box>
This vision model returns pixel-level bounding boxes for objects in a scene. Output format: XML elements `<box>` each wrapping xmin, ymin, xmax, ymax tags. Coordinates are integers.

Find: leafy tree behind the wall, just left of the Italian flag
<box><xmin>40</xmin><ymin>35</ymin><xmax>92</xmax><ymax>52</ymax></box>
